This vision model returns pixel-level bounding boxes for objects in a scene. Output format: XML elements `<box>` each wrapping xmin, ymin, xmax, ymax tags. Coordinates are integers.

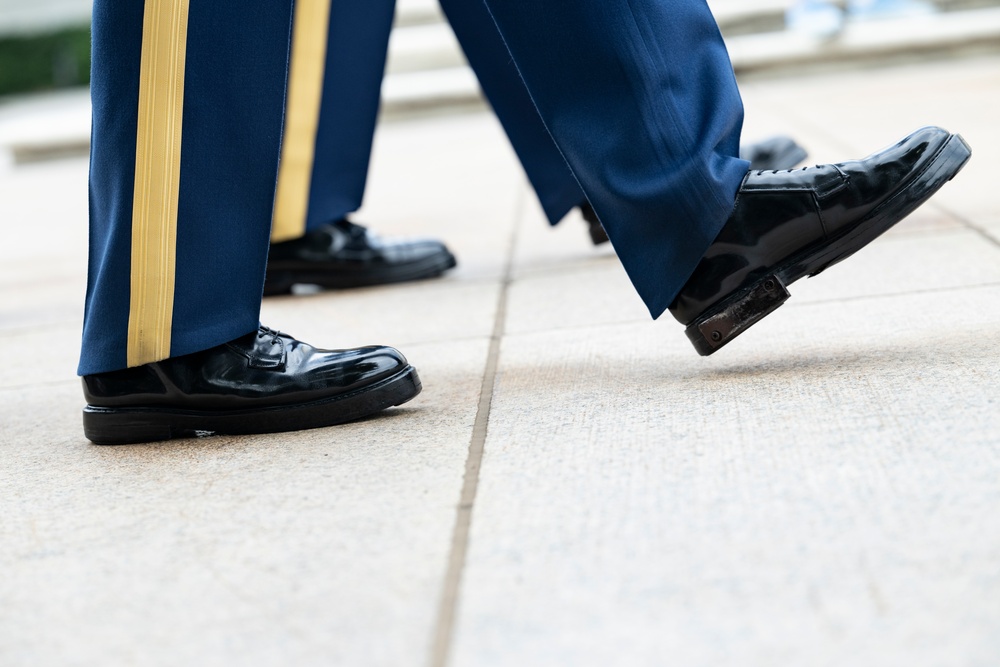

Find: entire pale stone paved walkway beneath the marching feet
<box><xmin>0</xmin><ymin>56</ymin><xmax>1000</xmax><ymax>667</ymax></box>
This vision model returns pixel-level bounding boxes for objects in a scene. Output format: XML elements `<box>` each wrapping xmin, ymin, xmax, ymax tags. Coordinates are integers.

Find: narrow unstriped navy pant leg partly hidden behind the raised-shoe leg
<box><xmin>440</xmin><ymin>0</ymin><xmax>586</xmax><ymax>225</ymax></box>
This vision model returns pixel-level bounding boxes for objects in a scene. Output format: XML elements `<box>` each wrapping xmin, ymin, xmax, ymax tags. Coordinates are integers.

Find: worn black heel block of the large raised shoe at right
<box><xmin>684</xmin><ymin>276</ymin><xmax>791</xmax><ymax>357</ymax></box>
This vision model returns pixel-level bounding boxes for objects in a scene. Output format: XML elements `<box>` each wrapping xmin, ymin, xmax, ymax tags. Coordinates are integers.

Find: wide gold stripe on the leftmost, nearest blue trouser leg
<box><xmin>127</xmin><ymin>0</ymin><xmax>188</xmax><ymax>366</ymax></box>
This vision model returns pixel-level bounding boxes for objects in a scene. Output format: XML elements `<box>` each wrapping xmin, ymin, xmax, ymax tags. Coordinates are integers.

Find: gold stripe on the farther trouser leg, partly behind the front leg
<box><xmin>271</xmin><ymin>0</ymin><xmax>330</xmax><ymax>242</ymax></box>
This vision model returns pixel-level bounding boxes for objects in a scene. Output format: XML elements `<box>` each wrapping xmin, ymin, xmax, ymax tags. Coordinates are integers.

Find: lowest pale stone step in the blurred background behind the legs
<box><xmin>0</xmin><ymin>6</ymin><xmax>1000</xmax><ymax>162</ymax></box>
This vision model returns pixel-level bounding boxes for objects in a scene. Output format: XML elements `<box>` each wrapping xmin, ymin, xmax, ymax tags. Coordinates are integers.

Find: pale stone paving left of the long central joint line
<box><xmin>0</xmin><ymin>108</ymin><xmax>524</xmax><ymax>667</ymax></box>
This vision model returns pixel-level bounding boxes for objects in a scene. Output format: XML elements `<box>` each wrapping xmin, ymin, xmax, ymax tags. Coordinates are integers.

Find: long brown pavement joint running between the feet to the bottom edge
<box><xmin>430</xmin><ymin>186</ymin><xmax>527</xmax><ymax>667</ymax></box>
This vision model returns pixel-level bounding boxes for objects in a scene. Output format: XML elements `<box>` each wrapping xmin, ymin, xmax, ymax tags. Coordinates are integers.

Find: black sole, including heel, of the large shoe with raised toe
<box><xmin>685</xmin><ymin>134</ymin><xmax>972</xmax><ymax>356</ymax></box>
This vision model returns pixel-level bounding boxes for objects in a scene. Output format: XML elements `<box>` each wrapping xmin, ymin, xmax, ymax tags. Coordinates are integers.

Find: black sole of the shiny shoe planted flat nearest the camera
<box><xmin>83</xmin><ymin>366</ymin><xmax>422</xmax><ymax>445</ymax></box>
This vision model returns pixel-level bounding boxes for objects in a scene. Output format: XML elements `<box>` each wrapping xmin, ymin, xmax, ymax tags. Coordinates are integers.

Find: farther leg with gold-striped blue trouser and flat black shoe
<box><xmin>264</xmin><ymin>0</ymin><xmax>455</xmax><ymax>295</ymax></box>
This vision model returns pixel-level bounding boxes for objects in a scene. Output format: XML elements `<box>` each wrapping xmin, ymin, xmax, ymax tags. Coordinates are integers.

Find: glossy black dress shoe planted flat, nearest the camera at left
<box><xmin>83</xmin><ymin>326</ymin><xmax>421</xmax><ymax>445</ymax></box>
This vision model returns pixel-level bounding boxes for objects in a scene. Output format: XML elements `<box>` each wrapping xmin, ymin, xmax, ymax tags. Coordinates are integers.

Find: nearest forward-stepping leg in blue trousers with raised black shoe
<box><xmin>486</xmin><ymin>0</ymin><xmax>971</xmax><ymax>354</ymax></box>
